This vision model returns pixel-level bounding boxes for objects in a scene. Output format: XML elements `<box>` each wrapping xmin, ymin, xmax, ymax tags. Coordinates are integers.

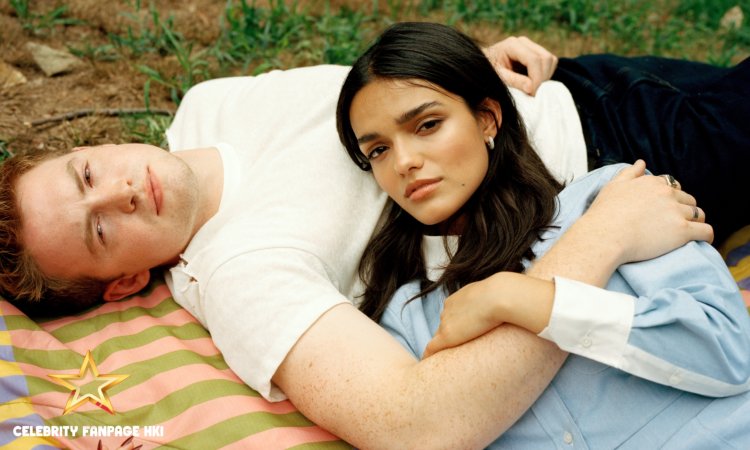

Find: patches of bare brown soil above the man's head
<box><xmin>0</xmin><ymin>0</ymin><xmax>225</xmax><ymax>152</ymax></box>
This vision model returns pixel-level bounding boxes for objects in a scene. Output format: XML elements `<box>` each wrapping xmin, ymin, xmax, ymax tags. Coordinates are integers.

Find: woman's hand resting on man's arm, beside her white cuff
<box><xmin>423</xmin><ymin>272</ymin><xmax>555</xmax><ymax>358</ymax></box>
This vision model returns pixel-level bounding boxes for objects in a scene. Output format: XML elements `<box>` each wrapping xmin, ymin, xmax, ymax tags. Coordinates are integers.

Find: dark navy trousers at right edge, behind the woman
<box><xmin>553</xmin><ymin>55</ymin><xmax>750</xmax><ymax>244</ymax></box>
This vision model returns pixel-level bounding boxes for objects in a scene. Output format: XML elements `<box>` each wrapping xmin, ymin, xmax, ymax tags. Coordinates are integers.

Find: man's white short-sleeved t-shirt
<box><xmin>167</xmin><ymin>66</ymin><xmax>585</xmax><ymax>400</ymax></box>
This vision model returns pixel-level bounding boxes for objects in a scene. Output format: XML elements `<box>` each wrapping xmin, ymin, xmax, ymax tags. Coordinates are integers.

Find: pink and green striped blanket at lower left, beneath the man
<box><xmin>0</xmin><ymin>280</ymin><xmax>351</xmax><ymax>450</ymax></box>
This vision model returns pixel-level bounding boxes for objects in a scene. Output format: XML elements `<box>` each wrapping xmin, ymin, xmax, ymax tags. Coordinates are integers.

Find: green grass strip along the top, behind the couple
<box><xmin>5</xmin><ymin>0</ymin><xmax>750</xmax><ymax>151</ymax></box>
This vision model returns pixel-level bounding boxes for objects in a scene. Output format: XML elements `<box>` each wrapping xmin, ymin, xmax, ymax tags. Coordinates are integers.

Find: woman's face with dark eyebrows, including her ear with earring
<box><xmin>349</xmin><ymin>80</ymin><xmax>500</xmax><ymax>225</ymax></box>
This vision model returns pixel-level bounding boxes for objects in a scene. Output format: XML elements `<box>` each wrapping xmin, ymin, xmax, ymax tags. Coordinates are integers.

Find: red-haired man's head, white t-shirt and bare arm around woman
<box><xmin>0</xmin><ymin>37</ymin><xmax>711</xmax><ymax>448</ymax></box>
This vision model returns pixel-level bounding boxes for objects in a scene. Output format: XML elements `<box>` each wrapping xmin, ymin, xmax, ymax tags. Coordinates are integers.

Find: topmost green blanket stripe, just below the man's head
<box><xmin>50</xmin><ymin>297</ymin><xmax>181</xmax><ymax>343</ymax></box>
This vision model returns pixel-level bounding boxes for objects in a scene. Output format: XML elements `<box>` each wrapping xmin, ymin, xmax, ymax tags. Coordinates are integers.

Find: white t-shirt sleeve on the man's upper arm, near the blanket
<box><xmin>198</xmin><ymin>249</ymin><xmax>348</xmax><ymax>401</ymax></box>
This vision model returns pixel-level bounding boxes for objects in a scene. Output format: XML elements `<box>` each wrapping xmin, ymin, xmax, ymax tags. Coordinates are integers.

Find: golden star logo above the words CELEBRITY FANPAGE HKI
<box><xmin>48</xmin><ymin>350</ymin><xmax>129</xmax><ymax>415</ymax></box>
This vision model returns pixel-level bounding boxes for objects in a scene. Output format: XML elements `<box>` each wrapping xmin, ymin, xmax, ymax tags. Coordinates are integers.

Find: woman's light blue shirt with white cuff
<box><xmin>381</xmin><ymin>165</ymin><xmax>750</xmax><ymax>449</ymax></box>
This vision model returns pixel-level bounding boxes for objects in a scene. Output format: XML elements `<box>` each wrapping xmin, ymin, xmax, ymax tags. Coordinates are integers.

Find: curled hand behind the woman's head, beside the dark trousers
<box><xmin>484</xmin><ymin>36</ymin><xmax>557</xmax><ymax>95</ymax></box>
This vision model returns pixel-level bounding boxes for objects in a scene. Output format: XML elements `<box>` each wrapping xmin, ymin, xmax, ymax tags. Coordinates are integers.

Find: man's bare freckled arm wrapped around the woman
<box><xmin>273</xmin><ymin>160</ymin><xmax>710</xmax><ymax>449</ymax></box>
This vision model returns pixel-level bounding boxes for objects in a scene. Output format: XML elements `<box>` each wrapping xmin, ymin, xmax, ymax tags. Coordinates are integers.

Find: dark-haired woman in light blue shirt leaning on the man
<box><xmin>337</xmin><ymin>23</ymin><xmax>750</xmax><ymax>448</ymax></box>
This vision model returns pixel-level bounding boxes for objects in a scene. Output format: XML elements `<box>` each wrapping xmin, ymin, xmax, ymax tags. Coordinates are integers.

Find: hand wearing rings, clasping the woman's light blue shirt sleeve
<box><xmin>579</xmin><ymin>160</ymin><xmax>713</xmax><ymax>265</ymax></box>
